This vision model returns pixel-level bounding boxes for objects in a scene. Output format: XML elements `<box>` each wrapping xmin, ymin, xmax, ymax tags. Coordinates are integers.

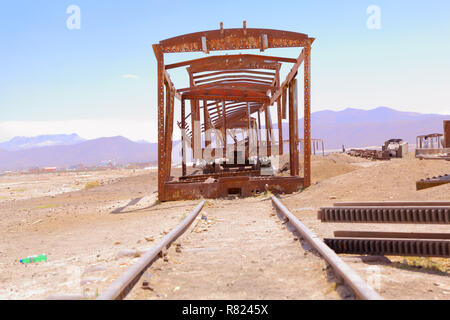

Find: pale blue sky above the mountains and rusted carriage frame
<box><xmin>0</xmin><ymin>0</ymin><xmax>450</xmax><ymax>141</ymax></box>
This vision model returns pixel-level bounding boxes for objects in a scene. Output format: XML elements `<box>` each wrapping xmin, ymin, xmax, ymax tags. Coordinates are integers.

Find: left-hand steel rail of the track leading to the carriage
<box><xmin>97</xmin><ymin>200</ymin><xmax>205</xmax><ymax>300</ymax></box>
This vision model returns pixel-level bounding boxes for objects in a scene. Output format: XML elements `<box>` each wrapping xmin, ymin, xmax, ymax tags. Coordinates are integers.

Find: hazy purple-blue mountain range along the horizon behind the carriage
<box><xmin>0</xmin><ymin>107</ymin><xmax>450</xmax><ymax>170</ymax></box>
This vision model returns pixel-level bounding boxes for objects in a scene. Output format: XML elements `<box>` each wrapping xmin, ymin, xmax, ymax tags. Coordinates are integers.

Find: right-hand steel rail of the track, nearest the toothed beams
<box><xmin>272</xmin><ymin>196</ymin><xmax>383</xmax><ymax>300</ymax></box>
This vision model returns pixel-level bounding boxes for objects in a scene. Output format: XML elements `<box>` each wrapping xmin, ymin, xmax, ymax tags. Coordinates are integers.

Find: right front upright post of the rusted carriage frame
<box><xmin>303</xmin><ymin>44</ymin><xmax>311</xmax><ymax>188</ymax></box>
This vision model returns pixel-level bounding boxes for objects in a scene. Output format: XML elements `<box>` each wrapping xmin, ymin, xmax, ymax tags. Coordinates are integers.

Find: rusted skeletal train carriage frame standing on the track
<box><xmin>153</xmin><ymin>21</ymin><xmax>315</xmax><ymax>201</ymax></box>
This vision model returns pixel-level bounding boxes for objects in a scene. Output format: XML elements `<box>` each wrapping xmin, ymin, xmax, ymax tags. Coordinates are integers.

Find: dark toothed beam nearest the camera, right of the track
<box><xmin>324</xmin><ymin>238</ymin><xmax>450</xmax><ymax>258</ymax></box>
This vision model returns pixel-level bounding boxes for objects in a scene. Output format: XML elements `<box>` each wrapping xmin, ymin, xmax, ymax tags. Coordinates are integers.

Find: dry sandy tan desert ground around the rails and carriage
<box><xmin>0</xmin><ymin>155</ymin><xmax>450</xmax><ymax>299</ymax></box>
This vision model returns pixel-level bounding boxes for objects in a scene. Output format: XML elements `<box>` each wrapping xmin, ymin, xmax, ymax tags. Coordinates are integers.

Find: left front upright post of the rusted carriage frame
<box><xmin>153</xmin><ymin>45</ymin><xmax>166</xmax><ymax>199</ymax></box>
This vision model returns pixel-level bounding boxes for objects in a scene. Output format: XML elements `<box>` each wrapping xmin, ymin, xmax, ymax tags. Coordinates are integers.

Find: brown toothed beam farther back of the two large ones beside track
<box><xmin>318</xmin><ymin>206</ymin><xmax>450</xmax><ymax>224</ymax></box>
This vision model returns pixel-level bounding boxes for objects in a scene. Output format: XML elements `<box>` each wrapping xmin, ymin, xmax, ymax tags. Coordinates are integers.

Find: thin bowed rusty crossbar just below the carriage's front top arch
<box><xmin>165</xmin><ymin>54</ymin><xmax>297</xmax><ymax>73</ymax></box>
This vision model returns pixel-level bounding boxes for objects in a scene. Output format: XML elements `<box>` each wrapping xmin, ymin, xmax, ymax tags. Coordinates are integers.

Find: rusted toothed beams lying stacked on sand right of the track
<box><xmin>318</xmin><ymin>201</ymin><xmax>450</xmax><ymax>258</ymax></box>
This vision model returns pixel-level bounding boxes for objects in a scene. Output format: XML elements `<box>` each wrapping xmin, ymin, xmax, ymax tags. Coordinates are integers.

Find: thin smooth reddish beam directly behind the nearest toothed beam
<box><xmin>334</xmin><ymin>231</ymin><xmax>450</xmax><ymax>240</ymax></box>
